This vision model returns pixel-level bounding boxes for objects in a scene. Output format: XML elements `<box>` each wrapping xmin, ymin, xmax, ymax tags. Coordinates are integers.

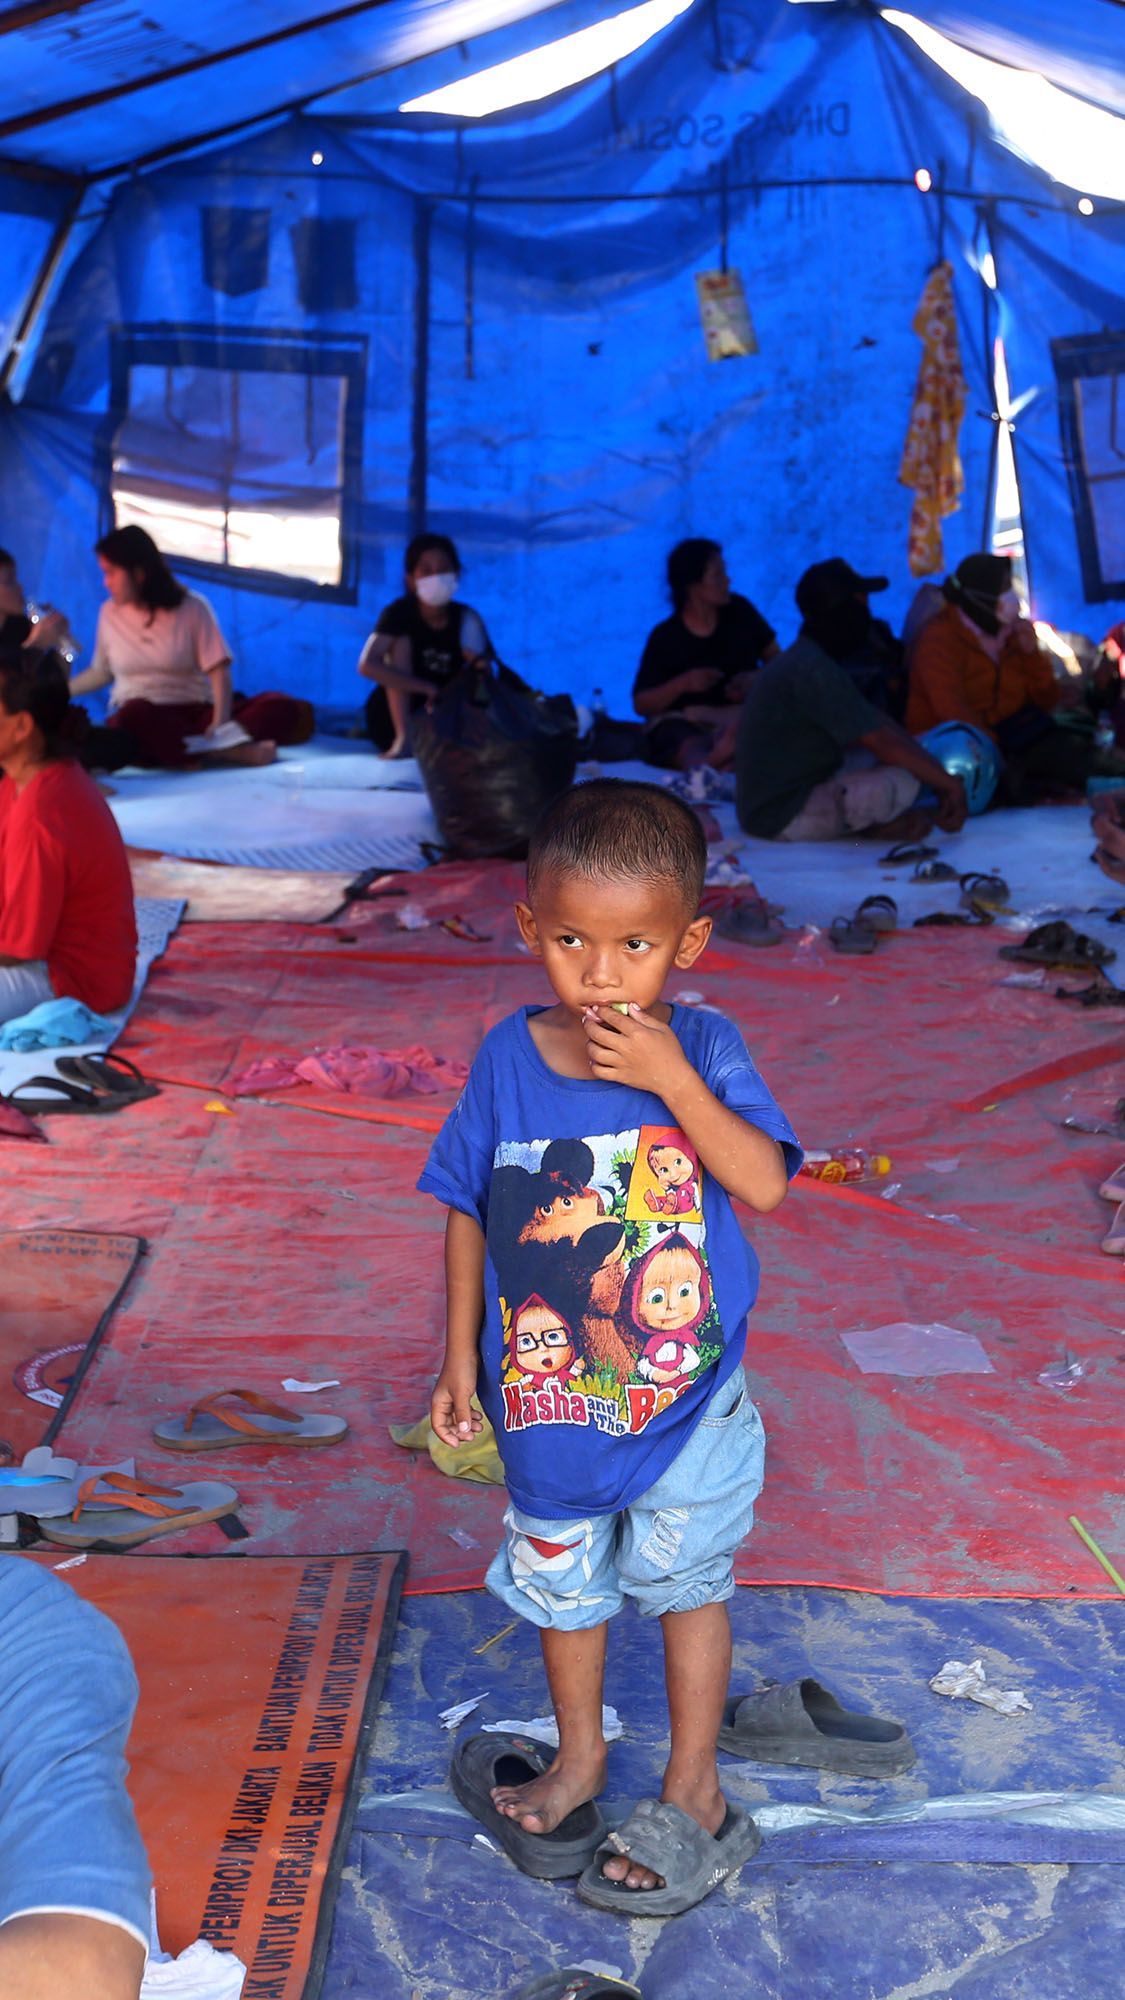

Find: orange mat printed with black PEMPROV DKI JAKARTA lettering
<box><xmin>27</xmin><ymin>1550</ymin><xmax>406</xmax><ymax>2000</ymax></box>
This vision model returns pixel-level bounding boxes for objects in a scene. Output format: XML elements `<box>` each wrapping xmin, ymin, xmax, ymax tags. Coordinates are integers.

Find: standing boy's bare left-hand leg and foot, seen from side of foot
<box><xmin>492</xmin><ymin>1624</ymin><xmax>604</xmax><ymax>1834</ymax></box>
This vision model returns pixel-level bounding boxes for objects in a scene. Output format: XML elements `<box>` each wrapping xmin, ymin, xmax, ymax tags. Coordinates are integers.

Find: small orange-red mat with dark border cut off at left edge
<box><xmin>0</xmin><ymin>1230</ymin><xmax>144</xmax><ymax>1460</ymax></box>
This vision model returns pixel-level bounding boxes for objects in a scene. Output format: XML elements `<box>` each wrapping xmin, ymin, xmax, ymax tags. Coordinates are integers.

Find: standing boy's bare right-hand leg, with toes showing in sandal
<box><xmin>603</xmin><ymin>1604</ymin><xmax>731</xmax><ymax>1888</ymax></box>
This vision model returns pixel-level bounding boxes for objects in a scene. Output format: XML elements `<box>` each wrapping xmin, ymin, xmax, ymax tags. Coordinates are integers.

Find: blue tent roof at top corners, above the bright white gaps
<box><xmin>0</xmin><ymin>0</ymin><xmax>1125</xmax><ymax>174</ymax></box>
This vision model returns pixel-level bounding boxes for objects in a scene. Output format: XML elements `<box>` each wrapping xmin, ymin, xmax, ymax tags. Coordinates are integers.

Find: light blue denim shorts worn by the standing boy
<box><xmin>484</xmin><ymin>1368</ymin><xmax>765</xmax><ymax>1632</ymax></box>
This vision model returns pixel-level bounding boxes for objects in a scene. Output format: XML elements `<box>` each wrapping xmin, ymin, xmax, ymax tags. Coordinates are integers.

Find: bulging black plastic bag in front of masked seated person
<box><xmin>410</xmin><ymin>666</ymin><xmax>579</xmax><ymax>860</ymax></box>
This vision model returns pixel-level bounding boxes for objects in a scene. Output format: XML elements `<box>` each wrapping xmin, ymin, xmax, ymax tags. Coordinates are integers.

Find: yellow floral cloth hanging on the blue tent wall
<box><xmin>899</xmin><ymin>264</ymin><xmax>965</xmax><ymax>576</ymax></box>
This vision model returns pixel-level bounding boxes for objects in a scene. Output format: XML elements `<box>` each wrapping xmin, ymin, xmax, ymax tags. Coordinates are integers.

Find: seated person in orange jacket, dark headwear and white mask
<box><xmin>907</xmin><ymin>554</ymin><xmax>1125</xmax><ymax>804</ymax></box>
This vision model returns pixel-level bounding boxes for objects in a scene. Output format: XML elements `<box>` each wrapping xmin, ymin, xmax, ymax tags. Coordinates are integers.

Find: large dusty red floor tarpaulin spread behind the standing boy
<box><xmin>2</xmin><ymin>870</ymin><xmax>1125</xmax><ymax>1596</ymax></box>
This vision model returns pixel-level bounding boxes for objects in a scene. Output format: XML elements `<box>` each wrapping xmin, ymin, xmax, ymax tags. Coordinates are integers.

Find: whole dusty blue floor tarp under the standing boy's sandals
<box><xmin>324</xmin><ymin>1590</ymin><xmax>1125</xmax><ymax>2000</ymax></box>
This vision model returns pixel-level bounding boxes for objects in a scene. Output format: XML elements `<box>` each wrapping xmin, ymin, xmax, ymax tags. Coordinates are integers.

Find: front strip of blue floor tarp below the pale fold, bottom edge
<box><xmin>320</xmin><ymin>1834</ymin><xmax>1125</xmax><ymax>2000</ymax></box>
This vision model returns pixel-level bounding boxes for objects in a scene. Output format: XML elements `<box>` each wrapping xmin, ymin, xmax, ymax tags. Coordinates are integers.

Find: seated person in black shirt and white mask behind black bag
<box><xmin>360</xmin><ymin>534</ymin><xmax>492</xmax><ymax>758</ymax></box>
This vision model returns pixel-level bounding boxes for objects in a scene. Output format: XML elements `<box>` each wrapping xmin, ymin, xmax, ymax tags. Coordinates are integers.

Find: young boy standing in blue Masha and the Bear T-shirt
<box><xmin>418</xmin><ymin>780</ymin><xmax>801</xmax><ymax>1916</ymax></box>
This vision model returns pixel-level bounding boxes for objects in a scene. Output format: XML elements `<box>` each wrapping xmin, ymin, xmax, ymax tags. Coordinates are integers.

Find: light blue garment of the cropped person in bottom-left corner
<box><xmin>0</xmin><ymin>1556</ymin><xmax>152</xmax><ymax>1950</ymax></box>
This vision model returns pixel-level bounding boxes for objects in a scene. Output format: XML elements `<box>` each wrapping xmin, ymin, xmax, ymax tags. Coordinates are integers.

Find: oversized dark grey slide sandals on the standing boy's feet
<box><xmin>450</xmin><ymin>1732</ymin><xmax>761</xmax><ymax>1920</ymax></box>
